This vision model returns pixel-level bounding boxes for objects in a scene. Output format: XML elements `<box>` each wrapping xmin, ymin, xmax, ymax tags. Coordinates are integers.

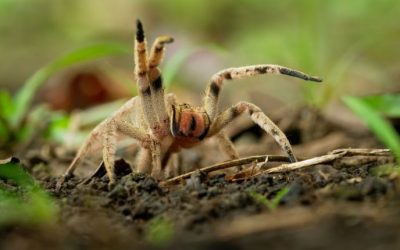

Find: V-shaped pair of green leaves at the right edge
<box><xmin>343</xmin><ymin>94</ymin><xmax>400</xmax><ymax>162</ymax></box>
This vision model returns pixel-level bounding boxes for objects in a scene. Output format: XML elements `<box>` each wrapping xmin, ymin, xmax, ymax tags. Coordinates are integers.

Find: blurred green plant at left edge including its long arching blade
<box><xmin>0</xmin><ymin>43</ymin><xmax>130</xmax><ymax>150</ymax></box>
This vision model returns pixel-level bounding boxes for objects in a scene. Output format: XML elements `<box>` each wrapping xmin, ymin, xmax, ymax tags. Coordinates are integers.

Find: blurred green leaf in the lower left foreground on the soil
<box><xmin>0</xmin><ymin>163</ymin><xmax>58</xmax><ymax>228</ymax></box>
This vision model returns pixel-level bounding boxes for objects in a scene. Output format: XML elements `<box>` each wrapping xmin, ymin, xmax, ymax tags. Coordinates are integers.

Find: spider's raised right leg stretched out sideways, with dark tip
<box><xmin>203</xmin><ymin>64</ymin><xmax>322</xmax><ymax>120</ymax></box>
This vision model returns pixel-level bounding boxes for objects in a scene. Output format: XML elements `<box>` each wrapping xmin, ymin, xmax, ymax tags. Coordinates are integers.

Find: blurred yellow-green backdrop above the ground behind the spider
<box><xmin>0</xmin><ymin>0</ymin><xmax>400</xmax><ymax>108</ymax></box>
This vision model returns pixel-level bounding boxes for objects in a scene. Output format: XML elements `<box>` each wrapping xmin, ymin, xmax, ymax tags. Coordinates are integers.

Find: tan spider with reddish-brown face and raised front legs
<box><xmin>58</xmin><ymin>20</ymin><xmax>322</xmax><ymax>187</ymax></box>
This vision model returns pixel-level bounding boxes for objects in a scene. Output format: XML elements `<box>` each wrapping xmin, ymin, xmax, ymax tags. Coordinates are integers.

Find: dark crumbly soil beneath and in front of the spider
<box><xmin>0</xmin><ymin>108</ymin><xmax>400</xmax><ymax>249</ymax></box>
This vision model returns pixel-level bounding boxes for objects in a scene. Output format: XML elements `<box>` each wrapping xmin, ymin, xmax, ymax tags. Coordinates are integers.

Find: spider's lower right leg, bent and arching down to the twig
<box><xmin>207</xmin><ymin>102</ymin><xmax>297</xmax><ymax>162</ymax></box>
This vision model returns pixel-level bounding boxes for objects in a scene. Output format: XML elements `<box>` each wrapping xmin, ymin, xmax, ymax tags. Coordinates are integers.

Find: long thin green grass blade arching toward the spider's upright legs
<box><xmin>11</xmin><ymin>43</ymin><xmax>131</xmax><ymax>128</ymax></box>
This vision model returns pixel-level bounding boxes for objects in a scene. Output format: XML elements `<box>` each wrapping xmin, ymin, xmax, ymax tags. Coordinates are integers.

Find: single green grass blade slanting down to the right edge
<box><xmin>342</xmin><ymin>96</ymin><xmax>400</xmax><ymax>161</ymax></box>
